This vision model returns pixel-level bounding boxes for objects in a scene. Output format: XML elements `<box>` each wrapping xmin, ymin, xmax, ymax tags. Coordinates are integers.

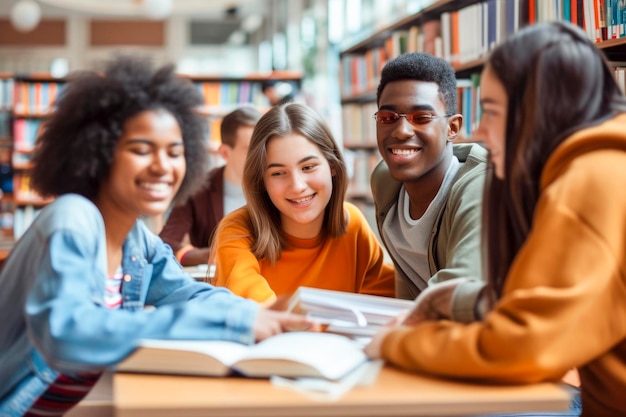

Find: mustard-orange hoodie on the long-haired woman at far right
<box><xmin>382</xmin><ymin>114</ymin><xmax>626</xmax><ymax>417</ymax></box>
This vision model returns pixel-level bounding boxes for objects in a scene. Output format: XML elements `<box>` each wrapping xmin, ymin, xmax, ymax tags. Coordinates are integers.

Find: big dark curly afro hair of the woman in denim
<box><xmin>32</xmin><ymin>56</ymin><xmax>208</xmax><ymax>202</ymax></box>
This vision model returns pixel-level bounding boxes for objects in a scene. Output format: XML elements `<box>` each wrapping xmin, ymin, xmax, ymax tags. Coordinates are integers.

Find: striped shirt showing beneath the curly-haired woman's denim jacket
<box><xmin>24</xmin><ymin>267</ymin><xmax>124</xmax><ymax>417</ymax></box>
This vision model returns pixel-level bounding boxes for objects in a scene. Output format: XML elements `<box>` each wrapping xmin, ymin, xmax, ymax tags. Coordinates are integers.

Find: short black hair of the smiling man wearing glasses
<box><xmin>376</xmin><ymin>52</ymin><xmax>457</xmax><ymax>114</ymax></box>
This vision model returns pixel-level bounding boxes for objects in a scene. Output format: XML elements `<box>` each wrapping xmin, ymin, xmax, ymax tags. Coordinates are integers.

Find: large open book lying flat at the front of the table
<box><xmin>116</xmin><ymin>332</ymin><xmax>367</xmax><ymax>380</ymax></box>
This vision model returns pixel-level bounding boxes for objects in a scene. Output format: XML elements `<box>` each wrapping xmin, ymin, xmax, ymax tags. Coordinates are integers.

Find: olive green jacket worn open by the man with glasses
<box><xmin>371</xmin><ymin>144</ymin><xmax>487</xmax><ymax>322</ymax></box>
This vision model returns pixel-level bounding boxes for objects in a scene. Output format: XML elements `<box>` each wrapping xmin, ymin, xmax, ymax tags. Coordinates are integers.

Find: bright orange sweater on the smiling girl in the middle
<box><xmin>215</xmin><ymin>203</ymin><xmax>394</xmax><ymax>302</ymax></box>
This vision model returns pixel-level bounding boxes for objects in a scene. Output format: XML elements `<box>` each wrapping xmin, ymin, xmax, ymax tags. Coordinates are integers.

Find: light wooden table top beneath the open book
<box><xmin>113</xmin><ymin>366</ymin><xmax>570</xmax><ymax>417</ymax></box>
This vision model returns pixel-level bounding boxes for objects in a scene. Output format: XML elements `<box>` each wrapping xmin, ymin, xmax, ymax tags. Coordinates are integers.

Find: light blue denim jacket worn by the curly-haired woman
<box><xmin>0</xmin><ymin>194</ymin><xmax>258</xmax><ymax>417</ymax></box>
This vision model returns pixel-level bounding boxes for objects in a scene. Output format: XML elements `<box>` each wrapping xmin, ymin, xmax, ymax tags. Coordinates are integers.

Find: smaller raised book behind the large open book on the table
<box><xmin>287</xmin><ymin>287</ymin><xmax>415</xmax><ymax>337</ymax></box>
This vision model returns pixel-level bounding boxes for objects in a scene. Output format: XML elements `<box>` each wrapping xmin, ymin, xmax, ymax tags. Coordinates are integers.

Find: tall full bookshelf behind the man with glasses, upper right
<box><xmin>339</xmin><ymin>0</ymin><xmax>626</xmax><ymax>221</ymax></box>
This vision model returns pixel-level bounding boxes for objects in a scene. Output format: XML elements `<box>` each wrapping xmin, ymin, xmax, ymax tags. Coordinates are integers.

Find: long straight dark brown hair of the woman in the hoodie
<box><xmin>483</xmin><ymin>22</ymin><xmax>626</xmax><ymax>297</ymax></box>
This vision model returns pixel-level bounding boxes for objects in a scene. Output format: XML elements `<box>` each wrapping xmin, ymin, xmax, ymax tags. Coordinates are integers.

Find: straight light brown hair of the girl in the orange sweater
<box><xmin>243</xmin><ymin>103</ymin><xmax>348</xmax><ymax>263</ymax></box>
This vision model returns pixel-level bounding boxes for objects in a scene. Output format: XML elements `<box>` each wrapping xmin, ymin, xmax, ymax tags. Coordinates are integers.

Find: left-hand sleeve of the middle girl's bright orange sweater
<box><xmin>214</xmin><ymin>207</ymin><xmax>276</xmax><ymax>303</ymax></box>
